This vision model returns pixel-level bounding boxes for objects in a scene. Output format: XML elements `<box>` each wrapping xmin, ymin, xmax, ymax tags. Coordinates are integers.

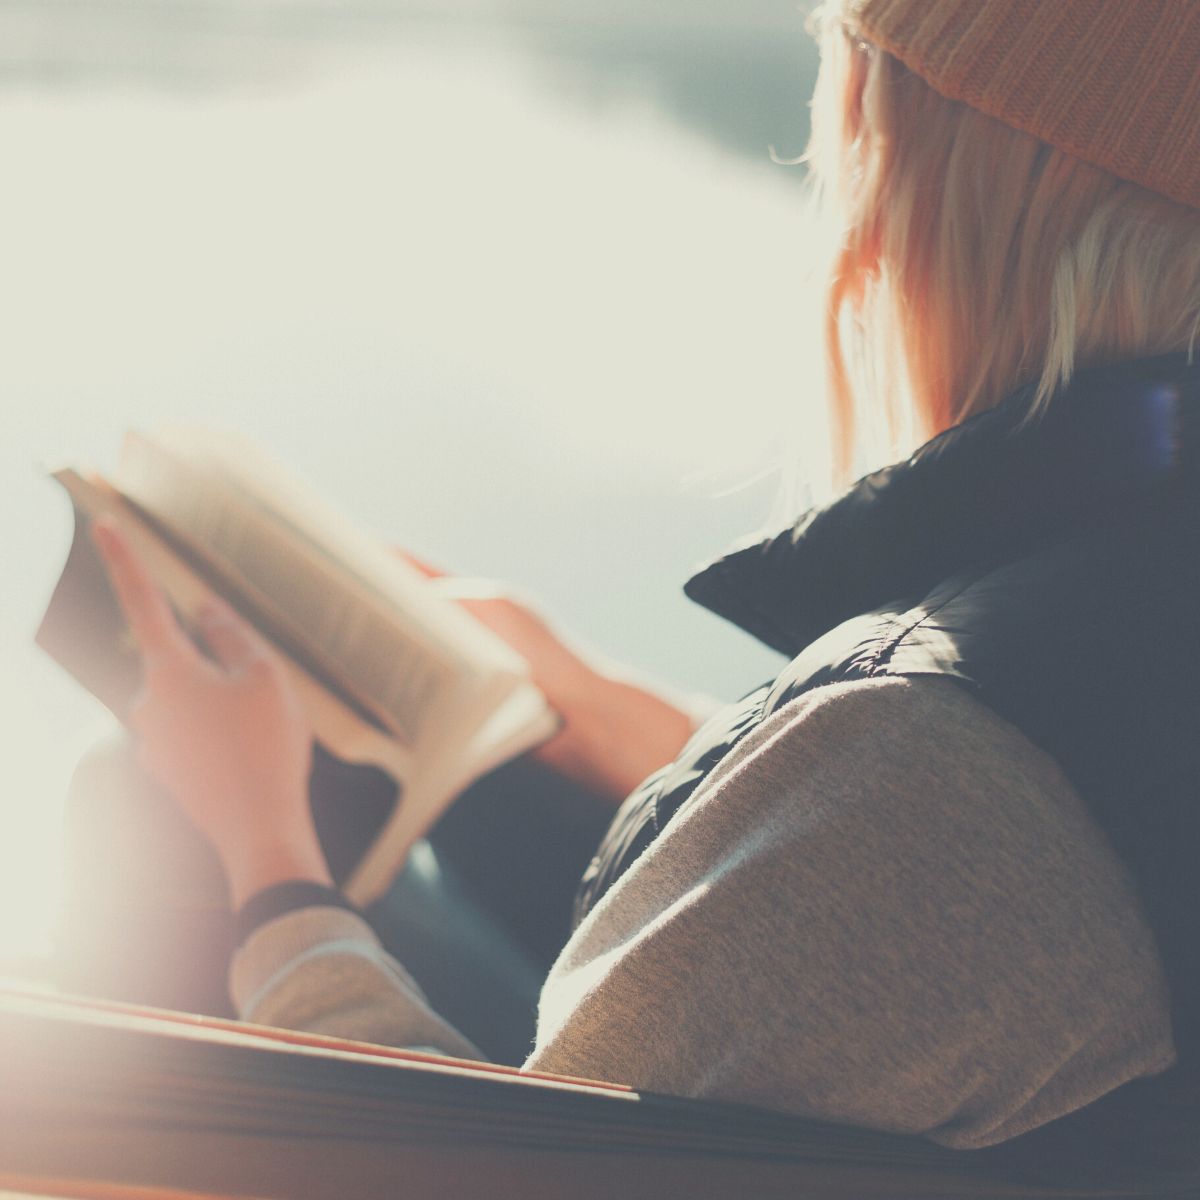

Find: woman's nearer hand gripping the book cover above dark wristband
<box><xmin>92</xmin><ymin>518</ymin><xmax>331</xmax><ymax>907</ymax></box>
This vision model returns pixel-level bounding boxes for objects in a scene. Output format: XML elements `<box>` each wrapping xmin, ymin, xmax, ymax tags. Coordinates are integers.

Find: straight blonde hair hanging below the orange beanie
<box><xmin>805</xmin><ymin>4</ymin><xmax>1200</xmax><ymax>479</ymax></box>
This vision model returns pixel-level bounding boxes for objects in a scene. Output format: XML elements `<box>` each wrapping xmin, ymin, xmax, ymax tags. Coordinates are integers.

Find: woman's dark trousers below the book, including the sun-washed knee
<box><xmin>55</xmin><ymin>737</ymin><xmax>612</xmax><ymax>1063</ymax></box>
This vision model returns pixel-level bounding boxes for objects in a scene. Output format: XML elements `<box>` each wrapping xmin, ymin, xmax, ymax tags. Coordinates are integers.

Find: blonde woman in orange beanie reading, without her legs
<box><xmin>88</xmin><ymin>0</ymin><xmax>1200</xmax><ymax>1161</ymax></box>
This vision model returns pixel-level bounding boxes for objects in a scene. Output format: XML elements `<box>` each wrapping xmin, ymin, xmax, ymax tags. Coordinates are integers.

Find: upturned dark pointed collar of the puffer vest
<box><xmin>685</xmin><ymin>354</ymin><xmax>1200</xmax><ymax>656</ymax></box>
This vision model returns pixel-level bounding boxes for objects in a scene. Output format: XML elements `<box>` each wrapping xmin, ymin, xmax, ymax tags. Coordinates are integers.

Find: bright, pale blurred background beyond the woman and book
<box><xmin>0</xmin><ymin>0</ymin><xmax>827</xmax><ymax>959</ymax></box>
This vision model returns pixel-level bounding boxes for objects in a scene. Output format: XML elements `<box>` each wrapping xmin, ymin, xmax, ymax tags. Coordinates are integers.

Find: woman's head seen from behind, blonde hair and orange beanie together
<box><xmin>809</xmin><ymin>0</ymin><xmax>1200</xmax><ymax>473</ymax></box>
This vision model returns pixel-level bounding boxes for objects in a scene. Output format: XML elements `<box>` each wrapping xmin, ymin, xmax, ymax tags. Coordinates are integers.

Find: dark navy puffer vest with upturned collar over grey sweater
<box><xmin>576</xmin><ymin>355</ymin><xmax>1200</xmax><ymax>1171</ymax></box>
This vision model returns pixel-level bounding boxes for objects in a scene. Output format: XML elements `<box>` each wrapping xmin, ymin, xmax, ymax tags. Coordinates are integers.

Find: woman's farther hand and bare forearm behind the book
<box><xmin>398</xmin><ymin>551</ymin><xmax>692</xmax><ymax>804</ymax></box>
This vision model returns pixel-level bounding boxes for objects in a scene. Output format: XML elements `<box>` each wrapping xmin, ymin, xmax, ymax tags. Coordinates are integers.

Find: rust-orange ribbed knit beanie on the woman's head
<box><xmin>846</xmin><ymin>0</ymin><xmax>1200</xmax><ymax>209</ymax></box>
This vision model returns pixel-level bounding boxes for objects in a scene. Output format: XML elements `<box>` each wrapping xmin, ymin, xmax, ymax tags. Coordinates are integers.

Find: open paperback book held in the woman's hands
<box><xmin>37</xmin><ymin>428</ymin><xmax>557</xmax><ymax>904</ymax></box>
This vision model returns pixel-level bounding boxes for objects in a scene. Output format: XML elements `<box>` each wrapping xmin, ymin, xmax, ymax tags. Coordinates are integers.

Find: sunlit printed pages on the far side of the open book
<box><xmin>113</xmin><ymin>428</ymin><xmax>540</xmax><ymax>746</ymax></box>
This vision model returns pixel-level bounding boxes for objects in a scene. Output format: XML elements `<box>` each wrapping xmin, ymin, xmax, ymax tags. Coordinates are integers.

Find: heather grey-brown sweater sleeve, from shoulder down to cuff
<box><xmin>225</xmin><ymin>680</ymin><xmax>1174</xmax><ymax>1147</ymax></box>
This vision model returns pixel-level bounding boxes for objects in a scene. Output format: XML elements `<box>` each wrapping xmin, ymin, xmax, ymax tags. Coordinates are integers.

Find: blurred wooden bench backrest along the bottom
<box><xmin>0</xmin><ymin>988</ymin><xmax>1051</xmax><ymax>1200</ymax></box>
